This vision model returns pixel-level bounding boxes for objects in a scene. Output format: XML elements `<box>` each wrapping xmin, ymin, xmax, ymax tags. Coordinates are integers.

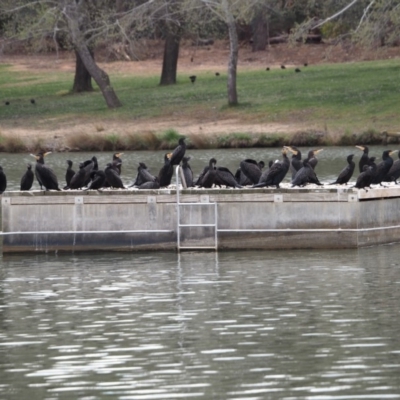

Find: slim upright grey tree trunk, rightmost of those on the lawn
<box><xmin>222</xmin><ymin>0</ymin><xmax>239</xmax><ymax>106</ymax></box>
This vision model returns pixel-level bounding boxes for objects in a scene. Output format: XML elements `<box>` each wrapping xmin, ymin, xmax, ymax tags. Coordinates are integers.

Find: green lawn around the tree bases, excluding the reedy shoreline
<box><xmin>0</xmin><ymin>60</ymin><xmax>400</xmax><ymax>140</ymax></box>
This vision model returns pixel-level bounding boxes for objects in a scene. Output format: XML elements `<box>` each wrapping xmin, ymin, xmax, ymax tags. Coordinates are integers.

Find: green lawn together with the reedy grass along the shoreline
<box><xmin>0</xmin><ymin>60</ymin><xmax>400</xmax><ymax>151</ymax></box>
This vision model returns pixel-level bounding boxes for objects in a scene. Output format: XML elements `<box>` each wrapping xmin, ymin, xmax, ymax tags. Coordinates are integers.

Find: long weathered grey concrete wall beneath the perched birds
<box><xmin>2</xmin><ymin>186</ymin><xmax>400</xmax><ymax>253</ymax></box>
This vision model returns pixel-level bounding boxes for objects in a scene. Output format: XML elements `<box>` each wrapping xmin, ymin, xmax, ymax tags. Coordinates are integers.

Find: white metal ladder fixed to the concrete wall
<box><xmin>175</xmin><ymin>165</ymin><xmax>218</xmax><ymax>252</ymax></box>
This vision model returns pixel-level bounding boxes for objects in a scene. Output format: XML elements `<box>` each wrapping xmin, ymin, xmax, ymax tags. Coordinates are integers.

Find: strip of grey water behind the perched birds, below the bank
<box><xmin>1</xmin><ymin>146</ymin><xmax>397</xmax><ymax>190</ymax></box>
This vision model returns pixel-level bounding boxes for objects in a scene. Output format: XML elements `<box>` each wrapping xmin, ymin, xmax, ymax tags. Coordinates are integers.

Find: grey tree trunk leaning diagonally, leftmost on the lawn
<box><xmin>63</xmin><ymin>0</ymin><xmax>122</xmax><ymax>108</ymax></box>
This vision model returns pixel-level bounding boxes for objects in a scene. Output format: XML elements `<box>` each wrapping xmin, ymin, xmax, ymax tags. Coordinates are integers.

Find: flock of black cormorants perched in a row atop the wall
<box><xmin>0</xmin><ymin>137</ymin><xmax>400</xmax><ymax>193</ymax></box>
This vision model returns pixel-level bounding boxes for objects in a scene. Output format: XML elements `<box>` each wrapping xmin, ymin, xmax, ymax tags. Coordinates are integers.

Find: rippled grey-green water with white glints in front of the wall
<box><xmin>0</xmin><ymin>245</ymin><xmax>400</xmax><ymax>400</ymax></box>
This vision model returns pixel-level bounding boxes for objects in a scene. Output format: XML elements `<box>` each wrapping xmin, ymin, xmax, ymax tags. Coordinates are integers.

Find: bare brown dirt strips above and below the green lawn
<box><xmin>0</xmin><ymin>41</ymin><xmax>400</xmax><ymax>145</ymax></box>
